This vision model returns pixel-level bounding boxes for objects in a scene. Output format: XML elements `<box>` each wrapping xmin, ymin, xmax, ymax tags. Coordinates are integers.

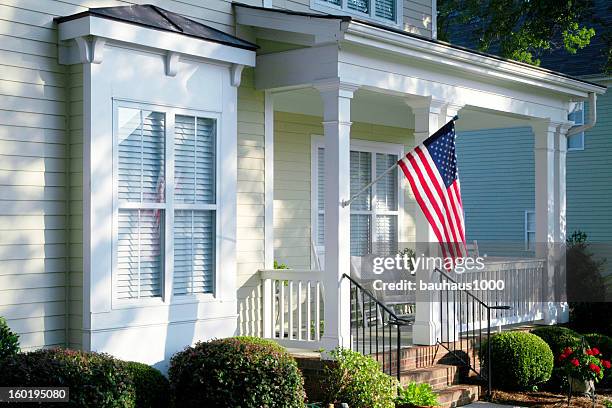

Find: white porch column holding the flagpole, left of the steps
<box><xmin>315</xmin><ymin>79</ymin><xmax>357</xmax><ymax>350</ymax></box>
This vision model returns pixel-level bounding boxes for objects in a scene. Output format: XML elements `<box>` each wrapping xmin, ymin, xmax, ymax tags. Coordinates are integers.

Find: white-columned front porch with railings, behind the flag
<box><xmin>236</xmin><ymin>6</ymin><xmax>598</xmax><ymax>352</ymax></box>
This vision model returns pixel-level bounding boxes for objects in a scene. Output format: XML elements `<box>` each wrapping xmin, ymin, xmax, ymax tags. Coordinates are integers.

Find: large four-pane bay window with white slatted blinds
<box><xmin>113</xmin><ymin>102</ymin><xmax>217</xmax><ymax>300</ymax></box>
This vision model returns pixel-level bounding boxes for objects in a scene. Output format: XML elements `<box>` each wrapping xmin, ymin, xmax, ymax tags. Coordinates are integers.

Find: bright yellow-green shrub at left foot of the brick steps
<box><xmin>323</xmin><ymin>348</ymin><xmax>397</xmax><ymax>408</ymax></box>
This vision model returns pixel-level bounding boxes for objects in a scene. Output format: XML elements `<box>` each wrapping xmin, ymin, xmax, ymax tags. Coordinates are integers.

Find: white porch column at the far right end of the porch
<box><xmin>533</xmin><ymin>121</ymin><xmax>569</xmax><ymax>324</ymax></box>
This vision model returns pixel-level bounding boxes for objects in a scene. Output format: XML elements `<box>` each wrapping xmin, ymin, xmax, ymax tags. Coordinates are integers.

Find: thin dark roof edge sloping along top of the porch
<box><xmin>232</xmin><ymin>2</ymin><xmax>601</xmax><ymax>87</ymax></box>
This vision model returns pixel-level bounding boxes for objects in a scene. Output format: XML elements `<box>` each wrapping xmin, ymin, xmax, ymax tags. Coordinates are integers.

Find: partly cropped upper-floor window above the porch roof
<box><xmin>311</xmin><ymin>0</ymin><xmax>403</xmax><ymax>25</ymax></box>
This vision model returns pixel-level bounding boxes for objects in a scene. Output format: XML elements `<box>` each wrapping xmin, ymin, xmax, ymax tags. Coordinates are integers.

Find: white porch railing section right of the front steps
<box><xmin>453</xmin><ymin>258</ymin><xmax>545</xmax><ymax>332</ymax></box>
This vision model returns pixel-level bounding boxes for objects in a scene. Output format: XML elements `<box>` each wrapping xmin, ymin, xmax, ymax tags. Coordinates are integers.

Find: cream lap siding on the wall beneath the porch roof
<box><xmin>274</xmin><ymin>112</ymin><xmax>414</xmax><ymax>269</ymax></box>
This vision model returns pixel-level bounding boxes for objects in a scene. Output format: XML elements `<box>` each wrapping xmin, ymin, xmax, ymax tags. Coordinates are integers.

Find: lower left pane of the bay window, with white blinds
<box><xmin>116</xmin><ymin>210</ymin><xmax>164</xmax><ymax>299</ymax></box>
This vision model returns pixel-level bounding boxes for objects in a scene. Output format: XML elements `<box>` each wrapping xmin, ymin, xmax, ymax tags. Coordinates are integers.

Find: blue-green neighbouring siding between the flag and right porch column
<box><xmin>457</xmin><ymin>127</ymin><xmax>535</xmax><ymax>249</ymax></box>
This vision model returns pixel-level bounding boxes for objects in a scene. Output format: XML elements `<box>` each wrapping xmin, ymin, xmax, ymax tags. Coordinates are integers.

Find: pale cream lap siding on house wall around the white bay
<box><xmin>0</xmin><ymin>0</ymin><xmax>263</xmax><ymax>349</ymax></box>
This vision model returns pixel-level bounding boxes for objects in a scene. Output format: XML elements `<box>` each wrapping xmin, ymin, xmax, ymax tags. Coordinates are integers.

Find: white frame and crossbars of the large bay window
<box><xmin>111</xmin><ymin>98</ymin><xmax>223</xmax><ymax>309</ymax></box>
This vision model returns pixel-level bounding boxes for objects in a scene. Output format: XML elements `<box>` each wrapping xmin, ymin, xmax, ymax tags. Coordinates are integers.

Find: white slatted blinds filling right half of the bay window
<box><xmin>173</xmin><ymin>115</ymin><xmax>216</xmax><ymax>295</ymax></box>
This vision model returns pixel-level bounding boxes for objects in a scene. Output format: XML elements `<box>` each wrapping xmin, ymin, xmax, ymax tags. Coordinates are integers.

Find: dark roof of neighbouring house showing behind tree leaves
<box><xmin>442</xmin><ymin>0</ymin><xmax>612</xmax><ymax>77</ymax></box>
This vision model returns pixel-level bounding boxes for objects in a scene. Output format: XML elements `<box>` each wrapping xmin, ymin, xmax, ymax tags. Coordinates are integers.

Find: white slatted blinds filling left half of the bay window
<box><xmin>115</xmin><ymin>108</ymin><xmax>165</xmax><ymax>299</ymax></box>
